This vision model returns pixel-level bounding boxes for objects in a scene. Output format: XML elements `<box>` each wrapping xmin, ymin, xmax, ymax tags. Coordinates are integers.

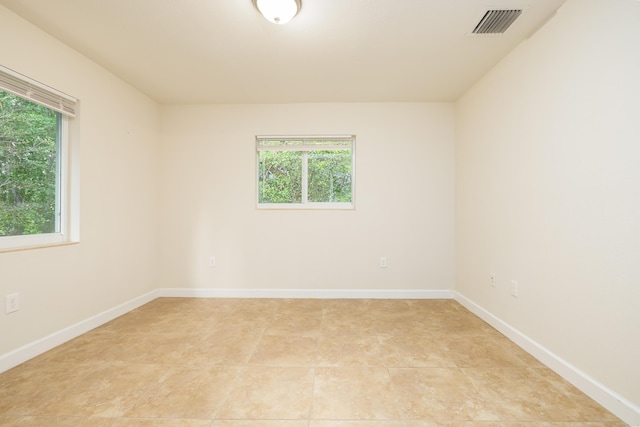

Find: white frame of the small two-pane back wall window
<box><xmin>255</xmin><ymin>135</ymin><xmax>356</xmax><ymax>210</ymax></box>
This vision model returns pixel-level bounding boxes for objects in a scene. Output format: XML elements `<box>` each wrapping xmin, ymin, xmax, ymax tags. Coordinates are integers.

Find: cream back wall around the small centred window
<box><xmin>160</xmin><ymin>103</ymin><xmax>454</xmax><ymax>290</ymax></box>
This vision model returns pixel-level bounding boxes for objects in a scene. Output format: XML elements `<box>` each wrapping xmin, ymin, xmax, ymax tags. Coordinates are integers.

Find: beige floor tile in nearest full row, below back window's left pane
<box><xmin>216</xmin><ymin>367</ymin><xmax>314</xmax><ymax>420</ymax></box>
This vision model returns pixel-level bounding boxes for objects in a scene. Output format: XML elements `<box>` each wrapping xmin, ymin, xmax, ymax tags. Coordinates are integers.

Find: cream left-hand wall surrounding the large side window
<box><xmin>0</xmin><ymin>6</ymin><xmax>158</xmax><ymax>356</ymax></box>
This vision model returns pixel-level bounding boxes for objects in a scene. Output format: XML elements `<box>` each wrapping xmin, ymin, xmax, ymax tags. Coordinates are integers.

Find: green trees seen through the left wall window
<box><xmin>0</xmin><ymin>90</ymin><xmax>60</xmax><ymax>236</ymax></box>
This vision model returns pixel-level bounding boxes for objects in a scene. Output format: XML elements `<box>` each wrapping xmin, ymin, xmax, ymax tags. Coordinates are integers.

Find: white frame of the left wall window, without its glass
<box><xmin>0</xmin><ymin>65</ymin><xmax>79</xmax><ymax>252</ymax></box>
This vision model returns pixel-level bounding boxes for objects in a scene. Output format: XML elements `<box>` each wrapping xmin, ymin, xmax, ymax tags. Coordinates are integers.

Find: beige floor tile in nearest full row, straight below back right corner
<box><xmin>389</xmin><ymin>368</ymin><xmax>499</xmax><ymax>421</ymax></box>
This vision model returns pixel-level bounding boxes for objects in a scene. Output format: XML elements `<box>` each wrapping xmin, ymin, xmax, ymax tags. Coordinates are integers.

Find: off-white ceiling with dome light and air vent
<box><xmin>0</xmin><ymin>0</ymin><xmax>565</xmax><ymax>104</ymax></box>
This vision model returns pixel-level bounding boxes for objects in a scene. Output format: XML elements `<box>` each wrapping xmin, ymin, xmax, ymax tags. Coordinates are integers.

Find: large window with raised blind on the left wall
<box><xmin>0</xmin><ymin>67</ymin><xmax>75</xmax><ymax>249</ymax></box>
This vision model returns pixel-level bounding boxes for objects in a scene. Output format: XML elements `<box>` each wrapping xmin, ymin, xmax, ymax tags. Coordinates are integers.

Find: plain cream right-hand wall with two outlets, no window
<box><xmin>456</xmin><ymin>0</ymin><xmax>640</xmax><ymax>414</ymax></box>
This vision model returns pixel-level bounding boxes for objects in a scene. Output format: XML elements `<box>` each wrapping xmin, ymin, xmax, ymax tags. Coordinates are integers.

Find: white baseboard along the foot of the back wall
<box><xmin>158</xmin><ymin>288</ymin><xmax>455</xmax><ymax>299</ymax></box>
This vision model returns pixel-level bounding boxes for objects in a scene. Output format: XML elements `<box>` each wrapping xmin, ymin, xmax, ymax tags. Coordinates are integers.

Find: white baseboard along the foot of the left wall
<box><xmin>0</xmin><ymin>289</ymin><xmax>159</xmax><ymax>373</ymax></box>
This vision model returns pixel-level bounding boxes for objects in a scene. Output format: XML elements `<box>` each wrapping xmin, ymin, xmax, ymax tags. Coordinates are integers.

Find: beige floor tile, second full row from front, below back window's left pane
<box><xmin>249</xmin><ymin>335</ymin><xmax>318</xmax><ymax>367</ymax></box>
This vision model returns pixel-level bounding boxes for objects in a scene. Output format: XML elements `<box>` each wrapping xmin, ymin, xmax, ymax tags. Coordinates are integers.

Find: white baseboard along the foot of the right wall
<box><xmin>455</xmin><ymin>292</ymin><xmax>640</xmax><ymax>426</ymax></box>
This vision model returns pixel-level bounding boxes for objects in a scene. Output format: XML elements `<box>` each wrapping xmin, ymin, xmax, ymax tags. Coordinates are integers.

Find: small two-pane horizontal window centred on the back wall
<box><xmin>256</xmin><ymin>135</ymin><xmax>355</xmax><ymax>209</ymax></box>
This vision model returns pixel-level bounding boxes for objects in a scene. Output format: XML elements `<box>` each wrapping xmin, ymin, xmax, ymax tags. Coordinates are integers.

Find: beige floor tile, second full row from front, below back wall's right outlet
<box><xmin>378</xmin><ymin>334</ymin><xmax>456</xmax><ymax>368</ymax></box>
